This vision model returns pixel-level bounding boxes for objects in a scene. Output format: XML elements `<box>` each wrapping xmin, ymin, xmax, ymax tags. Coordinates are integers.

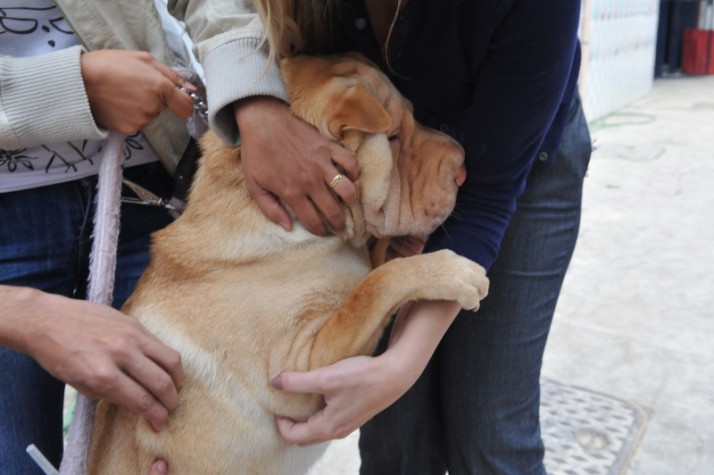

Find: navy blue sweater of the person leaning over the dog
<box><xmin>338</xmin><ymin>0</ymin><xmax>580</xmax><ymax>269</ymax></box>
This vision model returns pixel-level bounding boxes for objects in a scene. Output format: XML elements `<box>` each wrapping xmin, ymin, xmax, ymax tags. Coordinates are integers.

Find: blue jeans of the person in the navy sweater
<box><xmin>360</xmin><ymin>98</ymin><xmax>591</xmax><ymax>475</ymax></box>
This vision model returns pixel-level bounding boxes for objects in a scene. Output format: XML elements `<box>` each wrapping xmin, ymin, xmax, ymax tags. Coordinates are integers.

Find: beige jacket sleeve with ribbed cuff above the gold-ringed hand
<box><xmin>168</xmin><ymin>0</ymin><xmax>288</xmax><ymax>145</ymax></box>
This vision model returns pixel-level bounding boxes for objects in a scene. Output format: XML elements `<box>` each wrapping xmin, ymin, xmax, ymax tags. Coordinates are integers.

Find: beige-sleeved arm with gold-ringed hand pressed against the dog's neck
<box><xmin>168</xmin><ymin>0</ymin><xmax>358</xmax><ymax>234</ymax></box>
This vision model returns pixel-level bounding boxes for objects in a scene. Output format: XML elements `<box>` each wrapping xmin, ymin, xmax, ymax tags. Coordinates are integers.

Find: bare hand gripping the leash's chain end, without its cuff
<box><xmin>80</xmin><ymin>49</ymin><xmax>196</xmax><ymax>135</ymax></box>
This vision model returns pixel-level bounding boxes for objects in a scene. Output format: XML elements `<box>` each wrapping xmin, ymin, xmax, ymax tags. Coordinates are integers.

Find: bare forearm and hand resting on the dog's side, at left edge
<box><xmin>0</xmin><ymin>285</ymin><xmax>183</xmax><ymax>430</ymax></box>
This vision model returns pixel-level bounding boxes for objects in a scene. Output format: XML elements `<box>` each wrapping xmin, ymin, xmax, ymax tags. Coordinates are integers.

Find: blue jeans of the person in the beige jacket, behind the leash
<box><xmin>0</xmin><ymin>164</ymin><xmax>172</xmax><ymax>475</ymax></box>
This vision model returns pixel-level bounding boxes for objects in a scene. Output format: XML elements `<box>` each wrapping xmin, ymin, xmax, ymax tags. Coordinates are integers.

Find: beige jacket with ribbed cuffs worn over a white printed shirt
<box><xmin>0</xmin><ymin>0</ymin><xmax>286</xmax><ymax>170</ymax></box>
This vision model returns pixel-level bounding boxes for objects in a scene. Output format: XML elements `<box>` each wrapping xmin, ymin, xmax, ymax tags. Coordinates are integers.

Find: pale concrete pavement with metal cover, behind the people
<box><xmin>311</xmin><ymin>76</ymin><xmax>714</xmax><ymax>475</ymax></box>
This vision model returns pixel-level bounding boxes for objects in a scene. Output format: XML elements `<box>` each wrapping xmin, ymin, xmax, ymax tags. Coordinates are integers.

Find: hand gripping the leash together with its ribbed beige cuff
<box><xmin>0</xmin><ymin>46</ymin><xmax>193</xmax><ymax>150</ymax></box>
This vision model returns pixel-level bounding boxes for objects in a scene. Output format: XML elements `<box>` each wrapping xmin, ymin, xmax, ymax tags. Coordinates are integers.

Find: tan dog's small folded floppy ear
<box><xmin>327</xmin><ymin>84</ymin><xmax>392</xmax><ymax>138</ymax></box>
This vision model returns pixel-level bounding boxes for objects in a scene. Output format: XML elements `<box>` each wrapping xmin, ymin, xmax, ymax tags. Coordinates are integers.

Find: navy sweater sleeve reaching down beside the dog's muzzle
<box><xmin>427</xmin><ymin>0</ymin><xmax>579</xmax><ymax>269</ymax></box>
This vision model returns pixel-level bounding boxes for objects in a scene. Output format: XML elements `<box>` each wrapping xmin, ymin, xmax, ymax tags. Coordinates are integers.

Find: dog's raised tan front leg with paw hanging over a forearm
<box><xmin>310</xmin><ymin>250</ymin><xmax>488</xmax><ymax>369</ymax></box>
